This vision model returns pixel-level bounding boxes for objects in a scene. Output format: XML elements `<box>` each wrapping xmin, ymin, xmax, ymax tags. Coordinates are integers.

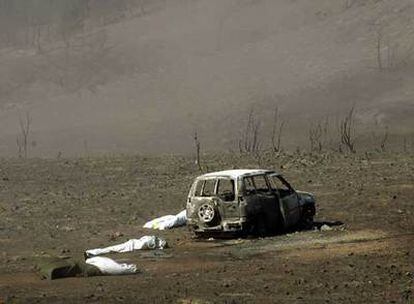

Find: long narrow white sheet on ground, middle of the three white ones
<box><xmin>85</xmin><ymin>235</ymin><xmax>168</xmax><ymax>257</ymax></box>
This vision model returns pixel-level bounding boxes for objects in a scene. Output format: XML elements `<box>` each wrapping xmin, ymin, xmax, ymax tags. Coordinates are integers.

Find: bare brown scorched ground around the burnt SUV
<box><xmin>0</xmin><ymin>154</ymin><xmax>414</xmax><ymax>303</ymax></box>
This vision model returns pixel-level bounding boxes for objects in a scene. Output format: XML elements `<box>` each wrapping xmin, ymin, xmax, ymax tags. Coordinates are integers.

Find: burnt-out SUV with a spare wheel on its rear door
<box><xmin>187</xmin><ymin>169</ymin><xmax>315</xmax><ymax>236</ymax></box>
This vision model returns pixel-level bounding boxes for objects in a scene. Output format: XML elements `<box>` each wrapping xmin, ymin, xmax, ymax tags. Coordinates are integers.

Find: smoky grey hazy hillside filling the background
<box><xmin>0</xmin><ymin>0</ymin><xmax>414</xmax><ymax>156</ymax></box>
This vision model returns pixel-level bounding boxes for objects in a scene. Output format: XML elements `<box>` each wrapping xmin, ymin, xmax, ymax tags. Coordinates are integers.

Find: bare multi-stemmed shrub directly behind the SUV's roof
<box><xmin>239</xmin><ymin>107</ymin><xmax>261</xmax><ymax>153</ymax></box>
